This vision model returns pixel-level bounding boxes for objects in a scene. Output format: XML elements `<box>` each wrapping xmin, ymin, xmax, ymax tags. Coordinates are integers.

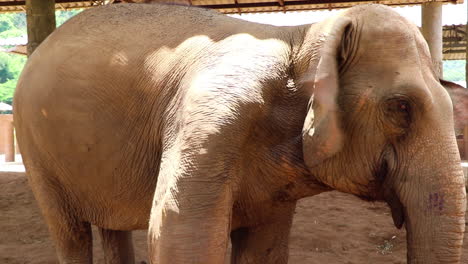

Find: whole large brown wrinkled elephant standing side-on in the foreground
<box><xmin>14</xmin><ymin>5</ymin><xmax>465</xmax><ymax>264</ymax></box>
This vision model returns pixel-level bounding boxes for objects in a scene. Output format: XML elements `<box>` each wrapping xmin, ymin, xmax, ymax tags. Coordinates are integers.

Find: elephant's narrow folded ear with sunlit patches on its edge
<box><xmin>302</xmin><ymin>17</ymin><xmax>352</xmax><ymax>167</ymax></box>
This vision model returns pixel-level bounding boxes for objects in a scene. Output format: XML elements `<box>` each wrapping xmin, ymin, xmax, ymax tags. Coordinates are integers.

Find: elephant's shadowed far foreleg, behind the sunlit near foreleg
<box><xmin>231</xmin><ymin>203</ymin><xmax>296</xmax><ymax>264</ymax></box>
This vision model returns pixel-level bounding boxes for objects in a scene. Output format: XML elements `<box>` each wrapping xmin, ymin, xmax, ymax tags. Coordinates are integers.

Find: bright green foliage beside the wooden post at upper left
<box><xmin>0</xmin><ymin>10</ymin><xmax>82</xmax><ymax>104</ymax></box>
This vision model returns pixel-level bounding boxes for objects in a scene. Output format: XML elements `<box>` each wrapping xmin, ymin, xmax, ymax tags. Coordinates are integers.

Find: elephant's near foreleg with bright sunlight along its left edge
<box><xmin>148</xmin><ymin>143</ymin><xmax>232</xmax><ymax>264</ymax></box>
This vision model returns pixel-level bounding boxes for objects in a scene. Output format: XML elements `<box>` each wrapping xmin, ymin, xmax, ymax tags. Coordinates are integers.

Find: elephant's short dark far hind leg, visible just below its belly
<box><xmin>99</xmin><ymin>228</ymin><xmax>135</xmax><ymax>264</ymax></box>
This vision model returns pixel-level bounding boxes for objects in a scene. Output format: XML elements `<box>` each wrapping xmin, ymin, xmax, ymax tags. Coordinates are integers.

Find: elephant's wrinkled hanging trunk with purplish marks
<box><xmin>397</xmin><ymin>136</ymin><xmax>466</xmax><ymax>264</ymax></box>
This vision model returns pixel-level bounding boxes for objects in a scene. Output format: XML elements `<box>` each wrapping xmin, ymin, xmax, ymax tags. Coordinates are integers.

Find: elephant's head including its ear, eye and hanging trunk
<box><xmin>302</xmin><ymin>5</ymin><xmax>466</xmax><ymax>264</ymax></box>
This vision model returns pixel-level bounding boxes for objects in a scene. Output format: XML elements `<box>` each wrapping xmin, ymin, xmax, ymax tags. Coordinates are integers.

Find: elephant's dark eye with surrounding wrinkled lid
<box><xmin>383</xmin><ymin>97</ymin><xmax>411</xmax><ymax>135</ymax></box>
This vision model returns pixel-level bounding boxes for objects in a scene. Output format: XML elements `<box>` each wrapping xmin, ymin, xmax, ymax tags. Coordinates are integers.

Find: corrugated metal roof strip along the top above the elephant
<box><xmin>0</xmin><ymin>0</ymin><xmax>463</xmax><ymax>14</ymax></box>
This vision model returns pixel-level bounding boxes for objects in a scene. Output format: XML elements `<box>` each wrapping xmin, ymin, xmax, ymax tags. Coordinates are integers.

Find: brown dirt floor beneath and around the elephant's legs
<box><xmin>0</xmin><ymin>172</ymin><xmax>468</xmax><ymax>264</ymax></box>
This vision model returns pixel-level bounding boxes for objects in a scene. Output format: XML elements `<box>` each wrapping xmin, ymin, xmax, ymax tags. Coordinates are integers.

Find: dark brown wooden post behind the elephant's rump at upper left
<box><xmin>26</xmin><ymin>0</ymin><xmax>55</xmax><ymax>56</ymax></box>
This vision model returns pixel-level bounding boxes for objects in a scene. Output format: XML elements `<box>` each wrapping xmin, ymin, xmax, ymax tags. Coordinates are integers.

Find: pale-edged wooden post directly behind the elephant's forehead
<box><xmin>421</xmin><ymin>2</ymin><xmax>443</xmax><ymax>78</ymax></box>
